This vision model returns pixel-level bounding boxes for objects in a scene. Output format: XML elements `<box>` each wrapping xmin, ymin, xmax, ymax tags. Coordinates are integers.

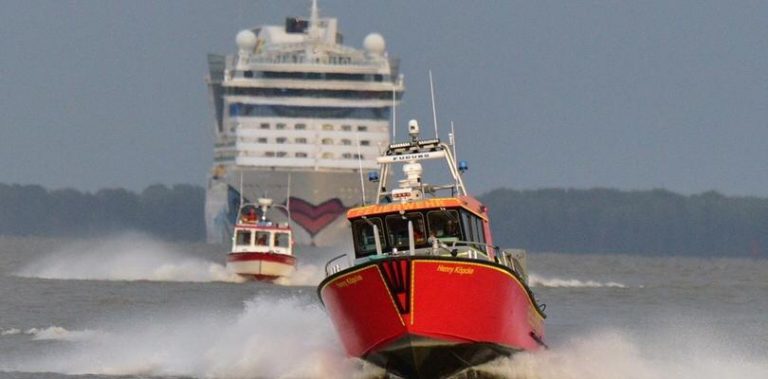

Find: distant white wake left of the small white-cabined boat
<box><xmin>16</xmin><ymin>235</ymin><xmax>244</xmax><ymax>283</ymax></box>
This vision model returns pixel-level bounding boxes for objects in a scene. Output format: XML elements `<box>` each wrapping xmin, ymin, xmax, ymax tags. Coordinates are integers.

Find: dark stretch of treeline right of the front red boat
<box><xmin>481</xmin><ymin>189</ymin><xmax>768</xmax><ymax>256</ymax></box>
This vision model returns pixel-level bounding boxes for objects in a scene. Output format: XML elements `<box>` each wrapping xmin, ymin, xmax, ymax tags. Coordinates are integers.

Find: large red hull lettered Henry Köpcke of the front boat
<box><xmin>318</xmin><ymin>257</ymin><xmax>544</xmax><ymax>378</ymax></box>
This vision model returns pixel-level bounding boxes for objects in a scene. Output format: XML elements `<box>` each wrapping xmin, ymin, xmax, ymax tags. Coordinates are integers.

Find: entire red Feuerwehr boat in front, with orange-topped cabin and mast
<box><xmin>318</xmin><ymin>120</ymin><xmax>546</xmax><ymax>378</ymax></box>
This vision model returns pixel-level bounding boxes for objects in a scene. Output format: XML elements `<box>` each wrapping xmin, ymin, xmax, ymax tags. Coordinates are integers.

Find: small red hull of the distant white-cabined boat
<box><xmin>227</xmin><ymin>252</ymin><xmax>296</xmax><ymax>281</ymax></box>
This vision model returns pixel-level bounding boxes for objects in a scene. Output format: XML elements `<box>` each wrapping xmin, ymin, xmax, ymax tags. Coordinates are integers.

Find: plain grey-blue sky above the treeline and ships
<box><xmin>0</xmin><ymin>0</ymin><xmax>768</xmax><ymax>197</ymax></box>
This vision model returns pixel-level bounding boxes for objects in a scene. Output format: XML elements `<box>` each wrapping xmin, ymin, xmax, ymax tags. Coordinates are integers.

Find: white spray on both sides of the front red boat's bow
<box><xmin>0</xmin><ymin>312</ymin><xmax>768</xmax><ymax>379</ymax></box>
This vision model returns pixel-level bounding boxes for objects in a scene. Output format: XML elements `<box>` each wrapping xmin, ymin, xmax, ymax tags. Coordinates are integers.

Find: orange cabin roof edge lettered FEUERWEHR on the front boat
<box><xmin>347</xmin><ymin>196</ymin><xmax>488</xmax><ymax>220</ymax></box>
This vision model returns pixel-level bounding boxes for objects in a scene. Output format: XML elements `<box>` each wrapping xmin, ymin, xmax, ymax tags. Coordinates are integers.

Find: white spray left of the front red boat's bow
<box><xmin>13</xmin><ymin>298</ymin><xmax>368</xmax><ymax>379</ymax></box>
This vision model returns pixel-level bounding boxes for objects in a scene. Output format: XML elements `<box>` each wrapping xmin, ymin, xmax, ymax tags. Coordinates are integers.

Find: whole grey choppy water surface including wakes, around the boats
<box><xmin>0</xmin><ymin>234</ymin><xmax>768</xmax><ymax>379</ymax></box>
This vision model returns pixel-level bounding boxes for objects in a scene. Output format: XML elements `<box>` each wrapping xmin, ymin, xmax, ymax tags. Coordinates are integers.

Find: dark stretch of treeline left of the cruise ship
<box><xmin>0</xmin><ymin>184</ymin><xmax>205</xmax><ymax>241</ymax></box>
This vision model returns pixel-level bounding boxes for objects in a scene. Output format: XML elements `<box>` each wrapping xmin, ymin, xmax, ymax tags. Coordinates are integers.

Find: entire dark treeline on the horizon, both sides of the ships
<box><xmin>0</xmin><ymin>184</ymin><xmax>768</xmax><ymax>256</ymax></box>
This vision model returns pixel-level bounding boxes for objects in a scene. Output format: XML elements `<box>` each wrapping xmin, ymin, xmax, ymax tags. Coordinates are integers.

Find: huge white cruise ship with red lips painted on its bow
<box><xmin>205</xmin><ymin>0</ymin><xmax>404</xmax><ymax>246</ymax></box>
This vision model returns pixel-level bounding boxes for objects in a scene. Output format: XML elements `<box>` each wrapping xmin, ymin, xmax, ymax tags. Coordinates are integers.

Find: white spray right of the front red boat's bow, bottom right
<box><xmin>481</xmin><ymin>329</ymin><xmax>768</xmax><ymax>379</ymax></box>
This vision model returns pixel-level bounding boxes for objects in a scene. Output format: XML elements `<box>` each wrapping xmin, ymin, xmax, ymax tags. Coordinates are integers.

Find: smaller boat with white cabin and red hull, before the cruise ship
<box><xmin>227</xmin><ymin>198</ymin><xmax>296</xmax><ymax>281</ymax></box>
